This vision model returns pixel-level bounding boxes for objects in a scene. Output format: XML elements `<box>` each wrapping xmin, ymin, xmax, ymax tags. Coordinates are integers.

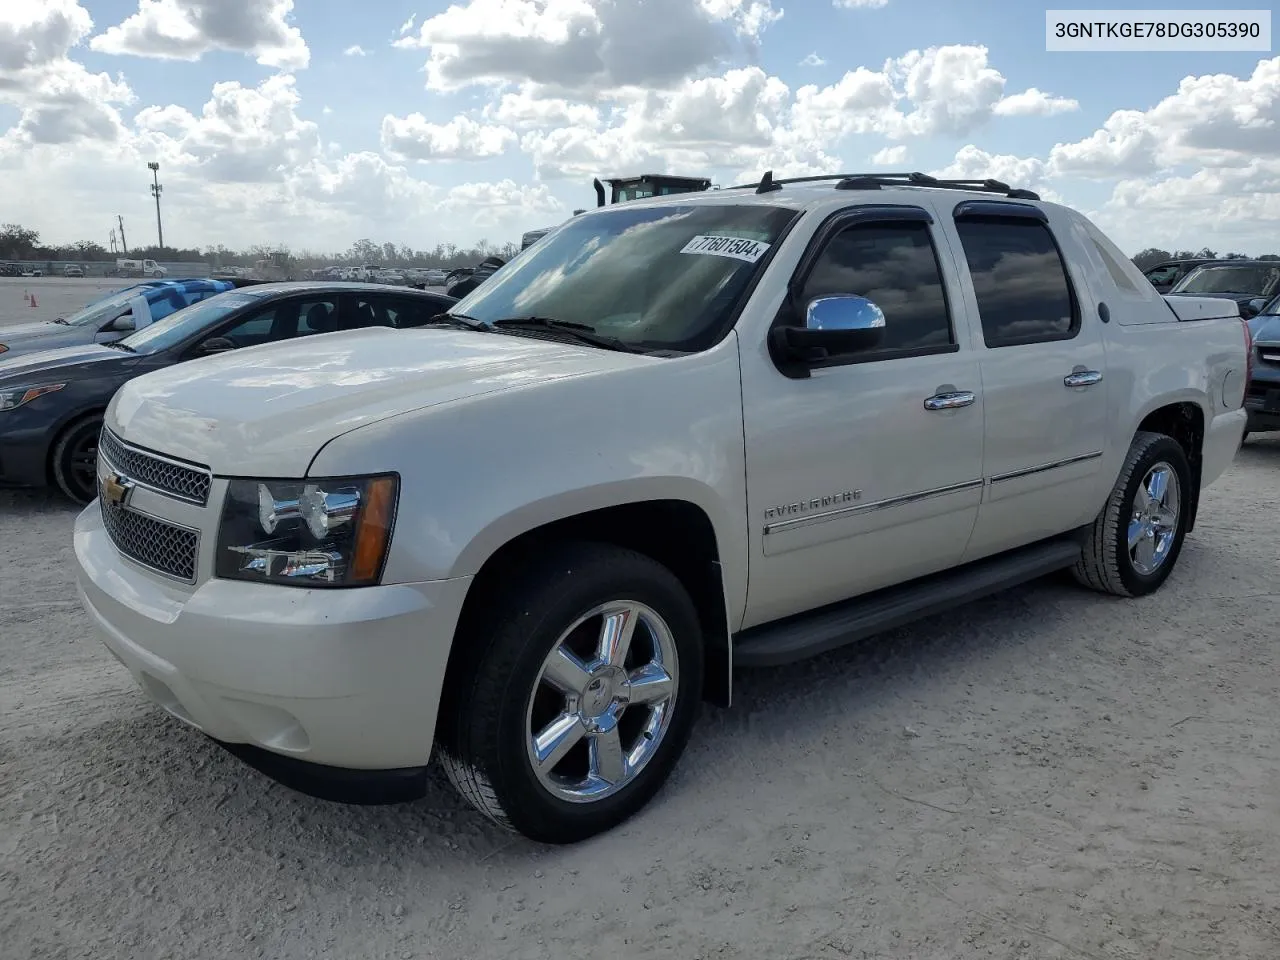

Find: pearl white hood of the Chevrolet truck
<box><xmin>108</xmin><ymin>326</ymin><xmax>662</xmax><ymax>476</ymax></box>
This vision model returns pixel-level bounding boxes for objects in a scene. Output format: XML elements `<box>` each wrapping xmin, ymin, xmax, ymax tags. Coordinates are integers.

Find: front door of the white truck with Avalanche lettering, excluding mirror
<box><xmin>741</xmin><ymin>207</ymin><xmax>983</xmax><ymax>627</ymax></box>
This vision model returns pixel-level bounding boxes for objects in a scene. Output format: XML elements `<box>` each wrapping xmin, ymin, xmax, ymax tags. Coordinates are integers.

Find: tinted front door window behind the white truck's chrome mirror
<box><xmin>803</xmin><ymin>221</ymin><xmax>955</xmax><ymax>356</ymax></box>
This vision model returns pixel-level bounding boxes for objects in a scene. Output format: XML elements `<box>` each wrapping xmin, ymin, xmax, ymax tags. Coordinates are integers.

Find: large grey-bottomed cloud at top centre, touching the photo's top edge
<box><xmin>396</xmin><ymin>0</ymin><xmax>781</xmax><ymax>99</ymax></box>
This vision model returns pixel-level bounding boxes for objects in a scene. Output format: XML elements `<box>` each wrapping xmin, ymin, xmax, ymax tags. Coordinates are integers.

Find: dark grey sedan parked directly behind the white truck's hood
<box><xmin>0</xmin><ymin>283</ymin><xmax>454</xmax><ymax>503</ymax></box>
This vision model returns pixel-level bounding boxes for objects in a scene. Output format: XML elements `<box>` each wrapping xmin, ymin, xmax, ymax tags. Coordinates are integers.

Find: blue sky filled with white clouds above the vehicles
<box><xmin>0</xmin><ymin>0</ymin><xmax>1280</xmax><ymax>255</ymax></box>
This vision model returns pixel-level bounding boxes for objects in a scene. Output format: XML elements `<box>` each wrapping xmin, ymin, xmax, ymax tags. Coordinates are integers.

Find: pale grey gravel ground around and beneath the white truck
<box><xmin>0</xmin><ymin>284</ymin><xmax>1280</xmax><ymax>960</ymax></box>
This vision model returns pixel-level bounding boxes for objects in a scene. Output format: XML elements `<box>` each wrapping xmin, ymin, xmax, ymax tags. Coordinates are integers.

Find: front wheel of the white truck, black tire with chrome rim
<box><xmin>438</xmin><ymin>543</ymin><xmax>703</xmax><ymax>844</ymax></box>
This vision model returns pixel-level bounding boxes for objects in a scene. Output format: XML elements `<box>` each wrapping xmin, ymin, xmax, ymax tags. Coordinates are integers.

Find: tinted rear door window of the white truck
<box><xmin>956</xmin><ymin>218</ymin><xmax>1079</xmax><ymax>347</ymax></box>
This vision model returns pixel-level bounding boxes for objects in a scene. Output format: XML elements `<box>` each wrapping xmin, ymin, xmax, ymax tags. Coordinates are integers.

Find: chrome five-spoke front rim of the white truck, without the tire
<box><xmin>526</xmin><ymin>600</ymin><xmax>680</xmax><ymax>803</ymax></box>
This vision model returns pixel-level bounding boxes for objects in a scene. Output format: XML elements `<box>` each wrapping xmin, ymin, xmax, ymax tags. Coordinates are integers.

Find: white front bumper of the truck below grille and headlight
<box><xmin>74</xmin><ymin>502</ymin><xmax>470</xmax><ymax>799</ymax></box>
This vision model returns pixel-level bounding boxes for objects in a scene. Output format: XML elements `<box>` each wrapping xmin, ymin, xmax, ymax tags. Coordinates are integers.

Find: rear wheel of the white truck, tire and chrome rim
<box><xmin>1073</xmin><ymin>431</ymin><xmax>1193</xmax><ymax>596</ymax></box>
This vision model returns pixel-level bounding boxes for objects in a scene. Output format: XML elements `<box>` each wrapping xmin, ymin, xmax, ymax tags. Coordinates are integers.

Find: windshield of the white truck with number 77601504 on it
<box><xmin>449</xmin><ymin>204</ymin><xmax>797</xmax><ymax>352</ymax></box>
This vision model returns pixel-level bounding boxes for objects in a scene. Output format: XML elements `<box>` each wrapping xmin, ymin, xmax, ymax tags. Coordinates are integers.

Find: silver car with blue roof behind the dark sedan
<box><xmin>0</xmin><ymin>279</ymin><xmax>244</xmax><ymax>358</ymax></box>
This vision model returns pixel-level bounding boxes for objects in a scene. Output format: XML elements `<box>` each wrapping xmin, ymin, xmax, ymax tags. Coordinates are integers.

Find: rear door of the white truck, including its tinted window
<box><xmin>948</xmin><ymin>200</ymin><xmax>1107</xmax><ymax>561</ymax></box>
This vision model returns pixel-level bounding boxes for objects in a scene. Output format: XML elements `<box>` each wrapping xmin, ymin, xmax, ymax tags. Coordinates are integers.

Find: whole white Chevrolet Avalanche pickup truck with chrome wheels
<box><xmin>74</xmin><ymin>175</ymin><xmax>1251</xmax><ymax>842</ymax></box>
